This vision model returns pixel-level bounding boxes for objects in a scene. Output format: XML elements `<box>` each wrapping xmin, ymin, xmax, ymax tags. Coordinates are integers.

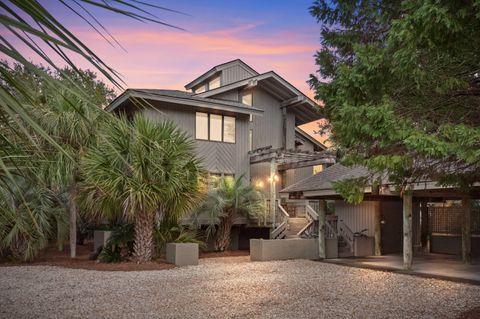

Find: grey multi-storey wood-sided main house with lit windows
<box><xmin>107</xmin><ymin>59</ymin><xmax>334</xmax><ymax>249</ymax></box>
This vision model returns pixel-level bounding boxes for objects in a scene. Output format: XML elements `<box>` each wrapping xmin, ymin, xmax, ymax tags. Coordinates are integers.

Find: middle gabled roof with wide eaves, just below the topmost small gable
<box><xmin>195</xmin><ymin>71</ymin><xmax>321</xmax><ymax>125</ymax></box>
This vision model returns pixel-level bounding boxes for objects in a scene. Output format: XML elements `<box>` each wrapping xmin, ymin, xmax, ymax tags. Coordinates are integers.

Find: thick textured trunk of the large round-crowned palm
<box><xmin>133</xmin><ymin>212</ymin><xmax>155</xmax><ymax>263</ymax></box>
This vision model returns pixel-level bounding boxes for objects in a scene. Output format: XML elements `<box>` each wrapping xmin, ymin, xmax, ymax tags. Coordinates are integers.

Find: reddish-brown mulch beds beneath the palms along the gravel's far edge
<box><xmin>0</xmin><ymin>243</ymin><xmax>249</xmax><ymax>271</ymax></box>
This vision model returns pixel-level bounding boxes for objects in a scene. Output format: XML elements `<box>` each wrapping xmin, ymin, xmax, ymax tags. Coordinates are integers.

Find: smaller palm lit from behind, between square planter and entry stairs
<box><xmin>199</xmin><ymin>175</ymin><xmax>265</xmax><ymax>251</ymax></box>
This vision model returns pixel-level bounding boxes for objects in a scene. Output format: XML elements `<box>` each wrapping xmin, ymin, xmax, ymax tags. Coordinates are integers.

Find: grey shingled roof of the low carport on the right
<box><xmin>280</xmin><ymin>164</ymin><xmax>369</xmax><ymax>193</ymax></box>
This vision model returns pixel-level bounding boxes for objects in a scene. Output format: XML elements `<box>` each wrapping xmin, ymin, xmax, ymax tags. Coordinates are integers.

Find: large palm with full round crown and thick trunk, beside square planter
<box><xmin>82</xmin><ymin>115</ymin><xmax>201</xmax><ymax>262</ymax></box>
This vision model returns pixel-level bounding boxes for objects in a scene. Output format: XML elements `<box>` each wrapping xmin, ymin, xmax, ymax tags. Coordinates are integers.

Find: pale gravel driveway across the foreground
<box><xmin>0</xmin><ymin>257</ymin><xmax>480</xmax><ymax>318</ymax></box>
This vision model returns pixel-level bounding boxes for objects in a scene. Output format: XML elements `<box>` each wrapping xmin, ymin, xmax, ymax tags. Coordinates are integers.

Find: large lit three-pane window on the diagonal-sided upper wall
<box><xmin>195</xmin><ymin>112</ymin><xmax>235</xmax><ymax>143</ymax></box>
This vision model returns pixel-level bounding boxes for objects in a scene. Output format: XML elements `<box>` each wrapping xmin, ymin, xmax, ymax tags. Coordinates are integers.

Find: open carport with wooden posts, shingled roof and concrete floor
<box><xmin>281</xmin><ymin>164</ymin><xmax>480</xmax><ymax>276</ymax></box>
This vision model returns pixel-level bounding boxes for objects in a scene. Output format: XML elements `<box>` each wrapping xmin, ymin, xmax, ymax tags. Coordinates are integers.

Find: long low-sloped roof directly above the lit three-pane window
<box><xmin>106</xmin><ymin>89</ymin><xmax>263</xmax><ymax>115</ymax></box>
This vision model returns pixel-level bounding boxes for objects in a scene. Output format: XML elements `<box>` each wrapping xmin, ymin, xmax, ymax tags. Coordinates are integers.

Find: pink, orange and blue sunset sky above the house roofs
<box><xmin>2</xmin><ymin>0</ymin><xmax>320</xmax><ymax>142</ymax></box>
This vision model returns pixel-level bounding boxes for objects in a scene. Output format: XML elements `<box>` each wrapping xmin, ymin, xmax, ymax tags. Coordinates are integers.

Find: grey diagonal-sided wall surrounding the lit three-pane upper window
<box><xmin>142</xmin><ymin>104</ymin><xmax>249</xmax><ymax>180</ymax></box>
